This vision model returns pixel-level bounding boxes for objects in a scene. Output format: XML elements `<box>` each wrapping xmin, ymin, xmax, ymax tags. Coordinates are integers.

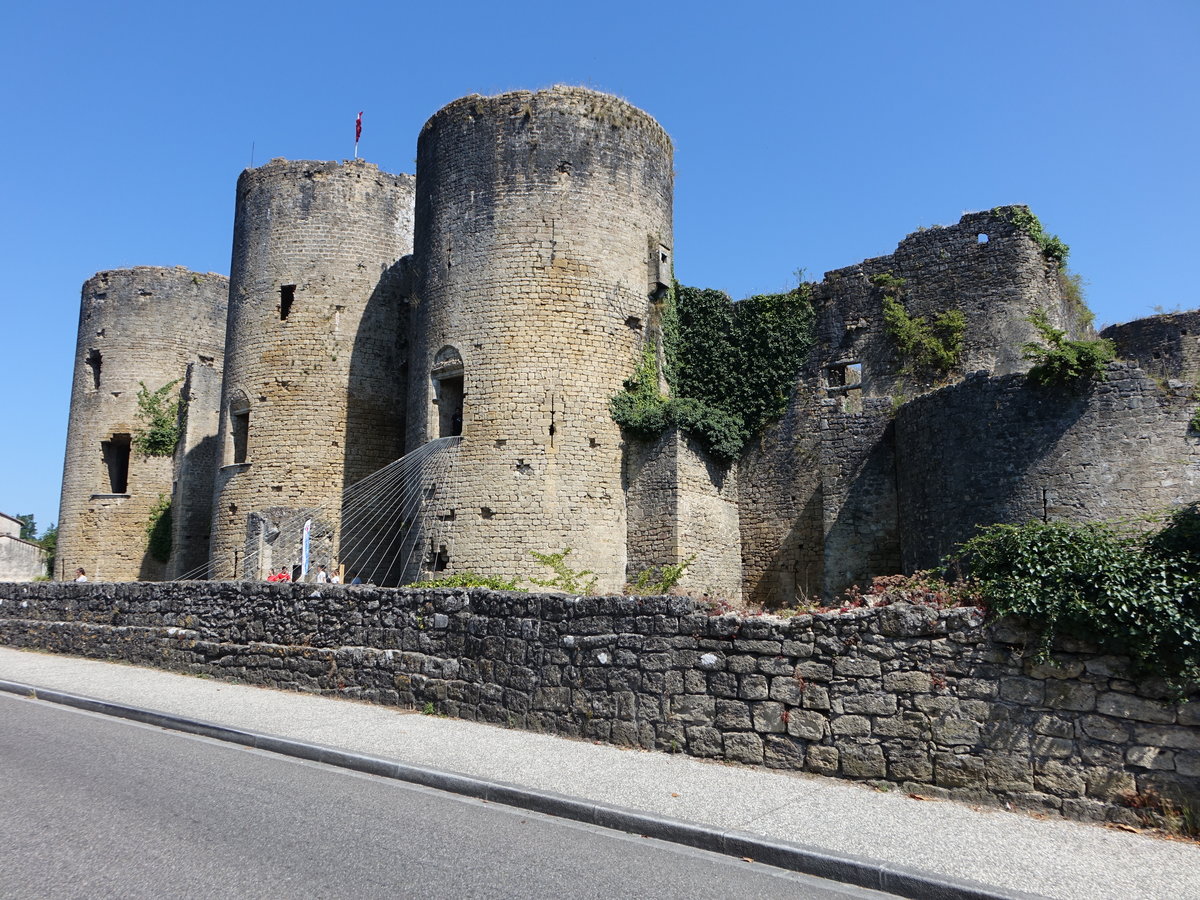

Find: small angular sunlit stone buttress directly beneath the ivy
<box><xmin>624</xmin><ymin>428</ymin><xmax>742</xmax><ymax>602</ymax></box>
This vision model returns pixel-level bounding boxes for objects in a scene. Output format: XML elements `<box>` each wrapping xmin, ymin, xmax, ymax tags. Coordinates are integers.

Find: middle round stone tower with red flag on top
<box><xmin>210</xmin><ymin>160</ymin><xmax>414</xmax><ymax>578</ymax></box>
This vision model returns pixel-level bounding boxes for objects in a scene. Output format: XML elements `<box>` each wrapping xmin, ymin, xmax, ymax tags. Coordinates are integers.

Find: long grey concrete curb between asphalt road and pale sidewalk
<box><xmin>0</xmin><ymin>680</ymin><xmax>1040</xmax><ymax>900</ymax></box>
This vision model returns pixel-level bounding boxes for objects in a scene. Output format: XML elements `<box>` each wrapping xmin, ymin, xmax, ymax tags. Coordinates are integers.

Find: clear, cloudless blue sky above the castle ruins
<box><xmin>0</xmin><ymin>0</ymin><xmax>1200</xmax><ymax>535</ymax></box>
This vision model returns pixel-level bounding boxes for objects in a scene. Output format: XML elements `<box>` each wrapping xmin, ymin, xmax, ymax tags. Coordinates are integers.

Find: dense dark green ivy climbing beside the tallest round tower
<box><xmin>610</xmin><ymin>284</ymin><xmax>814</xmax><ymax>460</ymax></box>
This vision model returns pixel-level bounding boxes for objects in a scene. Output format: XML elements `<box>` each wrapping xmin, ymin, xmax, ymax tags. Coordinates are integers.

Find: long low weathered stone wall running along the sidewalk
<box><xmin>0</xmin><ymin>582</ymin><xmax>1200</xmax><ymax>822</ymax></box>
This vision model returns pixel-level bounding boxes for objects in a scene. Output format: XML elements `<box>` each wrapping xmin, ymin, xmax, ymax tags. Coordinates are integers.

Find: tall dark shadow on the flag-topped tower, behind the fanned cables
<box><xmin>340</xmin><ymin>257</ymin><xmax>410</xmax><ymax>584</ymax></box>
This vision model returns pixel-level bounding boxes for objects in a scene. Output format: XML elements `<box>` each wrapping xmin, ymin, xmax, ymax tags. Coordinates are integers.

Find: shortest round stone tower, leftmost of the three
<box><xmin>55</xmin><ymin>266</ymin><xmax>229</xmax><ymax>581</ymax></box>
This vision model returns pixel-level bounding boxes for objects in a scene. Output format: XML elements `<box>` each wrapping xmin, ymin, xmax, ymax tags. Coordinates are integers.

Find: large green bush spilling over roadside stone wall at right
<box><xmin>955</xmin><ymin>518</ymin><xmax>1200</xmax><ymax>692</ymax></box>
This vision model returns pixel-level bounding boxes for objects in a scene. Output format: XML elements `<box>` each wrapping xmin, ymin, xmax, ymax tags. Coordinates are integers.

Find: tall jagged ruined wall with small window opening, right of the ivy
<box><xmin>739</xmin><ymin>209</ymin><xmax>1086</xmax><ymax>606</ymax></box>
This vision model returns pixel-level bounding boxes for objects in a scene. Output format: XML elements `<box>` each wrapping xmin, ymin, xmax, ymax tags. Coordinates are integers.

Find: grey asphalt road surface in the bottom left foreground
<box><xmin>0</xmin><ymin>695</ymin><xmax>884</xmax><ymax>900</ymax></box>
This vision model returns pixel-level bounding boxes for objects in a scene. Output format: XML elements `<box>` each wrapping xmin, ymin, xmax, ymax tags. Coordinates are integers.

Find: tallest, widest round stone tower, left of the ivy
<box><xmin>408</xmin><ymin>86</ymin><xmax>672</xmax><ymax>590</ymax></box>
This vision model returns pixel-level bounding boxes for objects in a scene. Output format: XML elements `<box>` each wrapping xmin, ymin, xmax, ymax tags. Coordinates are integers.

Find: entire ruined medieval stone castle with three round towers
<box><xmin>56</xmin><ymin>88</ymin><xmax>1200</xmax><ymax>605</ymax></box>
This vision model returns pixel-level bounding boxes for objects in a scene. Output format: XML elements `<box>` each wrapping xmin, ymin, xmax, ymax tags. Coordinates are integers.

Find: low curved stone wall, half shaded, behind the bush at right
<box><xmin>895</xmin><ymin>362</ymin><xmax>1200</xmax><ymax>571</ymax></box>
